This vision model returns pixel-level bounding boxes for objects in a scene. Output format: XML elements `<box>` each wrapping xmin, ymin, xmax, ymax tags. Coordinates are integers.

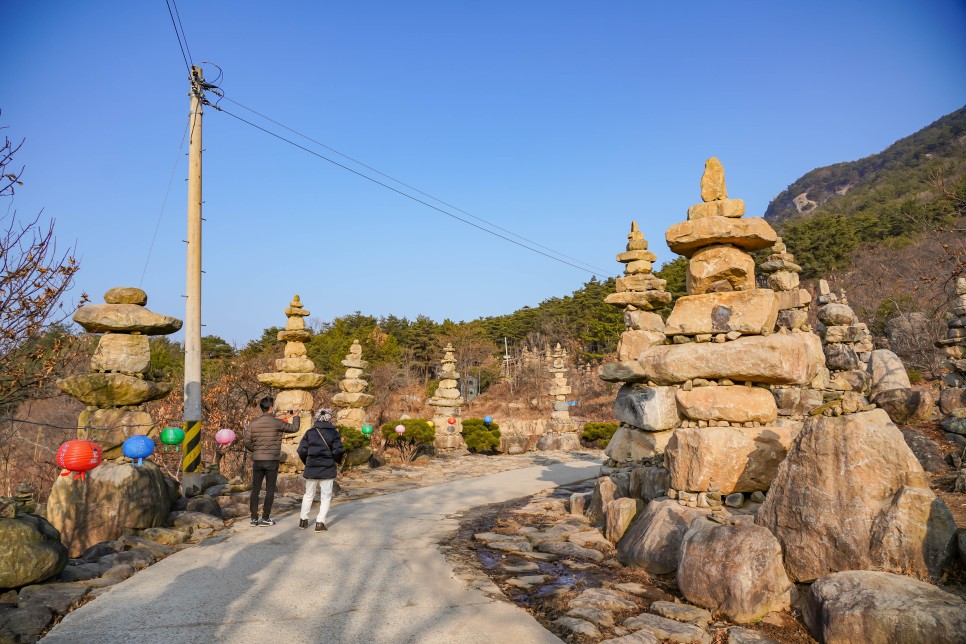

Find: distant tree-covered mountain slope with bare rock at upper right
<box><xmin>765</xmin><ymin>107</ymin><xmax>966</xmax><ymax>277</ymax></box>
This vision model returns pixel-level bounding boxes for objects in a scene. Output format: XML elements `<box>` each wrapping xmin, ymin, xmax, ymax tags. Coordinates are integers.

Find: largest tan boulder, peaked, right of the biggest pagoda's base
<box><xmin>757</xmin><ymin>409</ymin><xmax>955</xmax><ymax>582</ymax></box>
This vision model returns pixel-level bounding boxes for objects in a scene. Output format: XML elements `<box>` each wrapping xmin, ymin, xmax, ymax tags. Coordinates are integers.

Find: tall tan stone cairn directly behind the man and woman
<box><xmin>257</xmin><ymin>295</ymin><xmax>325</xmax><ymax>474</ymax></box>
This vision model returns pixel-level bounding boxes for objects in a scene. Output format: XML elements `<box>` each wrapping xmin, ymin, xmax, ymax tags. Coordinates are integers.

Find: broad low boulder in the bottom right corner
<box><xmin>802</xmin><ymin>570</ymin><xmax>966</xmax><ymax>644</ymax></box>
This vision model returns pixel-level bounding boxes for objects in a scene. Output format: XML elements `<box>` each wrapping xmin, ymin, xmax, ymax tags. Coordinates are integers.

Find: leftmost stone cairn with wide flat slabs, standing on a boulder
<box><xmin>57</xmin><ymin>287</ymin><xmax>181</xmax><ymax>459</ymax></box>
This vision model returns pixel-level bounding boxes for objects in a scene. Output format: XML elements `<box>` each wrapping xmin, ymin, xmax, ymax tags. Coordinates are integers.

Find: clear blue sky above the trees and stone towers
<box><xmin>0</xmin><ymin>0</ymin><xmax>966</xmax><ymax>345</ymax></box>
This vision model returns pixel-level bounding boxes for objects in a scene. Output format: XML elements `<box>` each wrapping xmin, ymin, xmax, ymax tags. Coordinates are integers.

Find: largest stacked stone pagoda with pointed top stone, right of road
<box><xmin>652</xmin><ymin>158</ymin><xmax>824</xmax><ymax>507</ymax></box>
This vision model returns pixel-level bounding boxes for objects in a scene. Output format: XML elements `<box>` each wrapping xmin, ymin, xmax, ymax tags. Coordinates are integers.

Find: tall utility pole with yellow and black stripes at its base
<box><xmin>181</xmin><ymin>66</ymin><xmax>205</xmax><ymax>487</ymax></box>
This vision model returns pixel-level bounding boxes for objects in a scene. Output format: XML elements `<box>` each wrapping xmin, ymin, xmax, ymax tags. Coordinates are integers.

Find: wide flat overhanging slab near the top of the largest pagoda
<box><xmin>664</xmin><ymin>217</ymin><xmax>778</xmax><ymax>257</ymax></box>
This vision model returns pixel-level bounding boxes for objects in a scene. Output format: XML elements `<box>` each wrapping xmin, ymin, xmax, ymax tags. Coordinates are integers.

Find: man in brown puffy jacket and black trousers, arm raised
<box><xmin>244</xmin><ymin>396</ymin><xmax>299</xmax><ymax>526</ymax></box>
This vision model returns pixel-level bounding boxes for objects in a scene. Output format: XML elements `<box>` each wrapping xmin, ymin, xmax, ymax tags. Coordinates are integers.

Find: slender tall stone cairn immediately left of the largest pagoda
<box><xmin>600</xmin><ymin>221</ymin><xmax>678</xmax><ymax>468</ymax></box>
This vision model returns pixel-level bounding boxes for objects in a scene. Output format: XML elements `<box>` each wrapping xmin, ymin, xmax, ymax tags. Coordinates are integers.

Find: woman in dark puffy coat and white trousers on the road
<box><xmin>298</xmin><ymin>407</ymin><xmax>345</xmax><ymax>532</ymax></box>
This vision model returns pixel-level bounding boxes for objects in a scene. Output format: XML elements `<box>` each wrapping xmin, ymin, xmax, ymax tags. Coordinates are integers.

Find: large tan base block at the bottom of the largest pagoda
<box><xmin>665</xmin><ymin>423</ymin><xmax>799</xmax><ymax>494</ymax></box>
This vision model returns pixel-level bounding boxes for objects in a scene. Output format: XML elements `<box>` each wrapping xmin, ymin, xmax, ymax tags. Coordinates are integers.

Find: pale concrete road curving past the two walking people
<box><xmin>49</xmin><ymin>460</ymin><xmax>600</xmax><ymax>644</ymax></box>
